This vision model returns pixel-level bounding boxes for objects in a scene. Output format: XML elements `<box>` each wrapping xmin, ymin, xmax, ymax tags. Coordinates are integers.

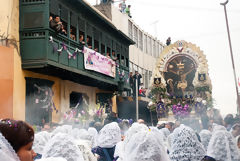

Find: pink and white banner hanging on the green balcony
<box><xmin>83</xmin><ymin>47</ymin><xmax>116</xmax><ymax>77</ymax></box>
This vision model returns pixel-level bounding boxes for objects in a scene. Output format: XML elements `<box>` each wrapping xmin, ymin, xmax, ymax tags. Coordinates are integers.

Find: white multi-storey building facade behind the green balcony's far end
<box><xmin>95</xmin><ymin>4</ymin><xmax>164</xmax><ymax>88</ymax></box>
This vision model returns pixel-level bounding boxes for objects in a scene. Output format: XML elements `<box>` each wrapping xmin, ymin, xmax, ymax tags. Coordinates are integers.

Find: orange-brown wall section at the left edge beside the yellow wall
<box><xmin>0</xmin><ymin>46</ymin><xmax>14</xmax><ymax>118</ymax></box>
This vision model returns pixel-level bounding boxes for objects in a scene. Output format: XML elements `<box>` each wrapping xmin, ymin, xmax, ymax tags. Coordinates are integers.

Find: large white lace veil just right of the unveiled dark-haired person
<box><xmin>43</xmin><ymin>133</ymin><xmax>84</xmax><ymax>161</ymax></box>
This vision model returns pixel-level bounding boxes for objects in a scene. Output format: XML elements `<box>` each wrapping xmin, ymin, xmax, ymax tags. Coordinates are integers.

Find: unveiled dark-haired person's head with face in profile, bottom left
<box><xmin>0</xmin><ymin>119</ymin><xmax>36</xmax><ymax>161</ymax></box>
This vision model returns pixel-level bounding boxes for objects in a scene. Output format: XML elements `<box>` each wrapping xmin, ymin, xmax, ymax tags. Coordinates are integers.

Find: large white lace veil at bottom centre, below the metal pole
<box><xmin>123</xmin><ymin>130</ymin><xmax>169</xmax><ymax>161</ymax></box>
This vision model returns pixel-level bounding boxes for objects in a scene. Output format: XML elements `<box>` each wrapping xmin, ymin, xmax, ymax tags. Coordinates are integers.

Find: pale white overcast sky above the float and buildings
<box><xmin>87</xmin><ymin>0</ymin><xmax>240</xmax><ymax>115</ymax></box>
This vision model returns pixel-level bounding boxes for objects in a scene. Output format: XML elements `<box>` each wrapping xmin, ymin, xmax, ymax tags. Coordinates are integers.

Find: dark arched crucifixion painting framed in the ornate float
<box><xmin>164</xmin><ymin>56</ymin><xmax>197</xmax><ymax>97</ymax></box>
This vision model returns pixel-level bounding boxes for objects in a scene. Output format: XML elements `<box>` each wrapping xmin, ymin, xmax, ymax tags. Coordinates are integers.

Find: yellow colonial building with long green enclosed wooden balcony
<box><xmin>0</xmin><ymin>0</ymin><xmax>134</xmax><ymax>124</ymax></box>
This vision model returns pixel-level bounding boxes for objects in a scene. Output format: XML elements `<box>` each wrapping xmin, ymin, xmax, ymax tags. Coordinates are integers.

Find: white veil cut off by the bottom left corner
<box><xmin>0</xmin><ymin>132</ymin><xmax>20</xmax><ymax>161</ymax></box>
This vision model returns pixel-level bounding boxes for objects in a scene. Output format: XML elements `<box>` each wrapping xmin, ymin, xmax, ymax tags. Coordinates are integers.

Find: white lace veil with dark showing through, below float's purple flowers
<box><xmin>169</xmin><ymin>125</ymin><xmax>206</xmax><ymax>161</ymax></box>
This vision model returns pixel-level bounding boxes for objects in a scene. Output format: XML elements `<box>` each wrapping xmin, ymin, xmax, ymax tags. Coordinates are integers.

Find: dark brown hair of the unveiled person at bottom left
<box><xmin>0</xmin><ymin>119</ymin><xmax>34</xmax><ymax>153</ymax></box>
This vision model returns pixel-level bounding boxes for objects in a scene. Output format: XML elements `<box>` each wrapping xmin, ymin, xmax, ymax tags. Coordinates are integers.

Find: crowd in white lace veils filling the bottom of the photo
<box><xmin>0</xmin><ymin>114</ymin><xmax>240</xmax><ymax>161</ymax></box>
